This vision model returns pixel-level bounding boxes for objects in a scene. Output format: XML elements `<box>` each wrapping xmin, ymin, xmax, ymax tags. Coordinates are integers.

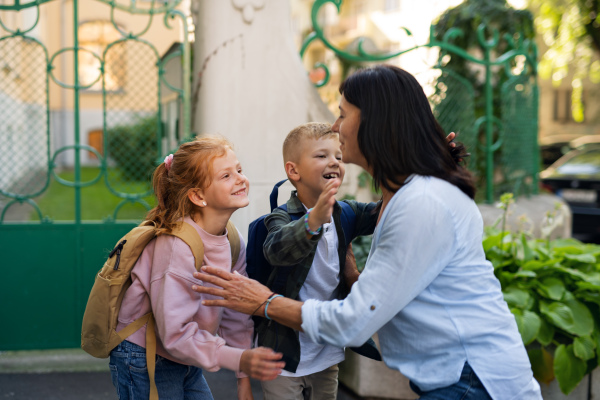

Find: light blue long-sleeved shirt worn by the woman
<box><xmin>302</xmin><ymin>175</ymin><xmax>541</xmax><ymax>400</ymax></box>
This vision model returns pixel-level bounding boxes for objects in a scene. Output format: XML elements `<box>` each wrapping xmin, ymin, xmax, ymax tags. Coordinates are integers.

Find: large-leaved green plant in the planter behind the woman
<box><xmin>483</xmin><ymin>196</ymin><xmax>600</xmax><ymax>394</ymax></box>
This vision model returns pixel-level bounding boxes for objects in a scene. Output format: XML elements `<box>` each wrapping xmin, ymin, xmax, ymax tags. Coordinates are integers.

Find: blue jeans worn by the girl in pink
<box><xmin>109</xmin><ymin>340</ymin><xmax>213</xmax><ymax>400</ymax></box>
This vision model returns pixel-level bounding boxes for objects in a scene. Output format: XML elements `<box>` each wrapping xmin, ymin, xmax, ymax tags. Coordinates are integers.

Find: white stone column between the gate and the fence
<box><xmin>192</xmin><ymin>0</ymin><xmax>334</xmax><ymax>236</ymax></box>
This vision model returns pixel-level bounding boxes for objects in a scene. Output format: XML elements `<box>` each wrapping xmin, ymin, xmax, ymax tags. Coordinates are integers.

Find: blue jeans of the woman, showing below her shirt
<box><xmin>410</xmin><ymin>363</ymin><xmax>492</xmax><ymax>400</ymax></box>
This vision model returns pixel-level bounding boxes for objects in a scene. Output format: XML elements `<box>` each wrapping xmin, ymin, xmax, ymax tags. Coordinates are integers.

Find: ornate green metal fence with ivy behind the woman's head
<box><xmin>300</xmin><ymin>0</ymin><xmax>539</xmax><ymax>203</ymax></box>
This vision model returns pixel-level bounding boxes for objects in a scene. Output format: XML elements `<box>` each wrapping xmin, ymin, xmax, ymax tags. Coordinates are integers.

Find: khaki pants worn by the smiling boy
<box><xmin>261</xmin><ymin>365</ymin><xmax>339</xmax><ymax>400</ymax></box>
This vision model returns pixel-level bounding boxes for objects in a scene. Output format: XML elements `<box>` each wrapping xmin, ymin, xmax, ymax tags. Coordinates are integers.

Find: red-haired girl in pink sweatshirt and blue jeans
<box><xmin>110</xmin><ymin>137</ymin><xmax>283</xmax><ymax>400</ymax></box>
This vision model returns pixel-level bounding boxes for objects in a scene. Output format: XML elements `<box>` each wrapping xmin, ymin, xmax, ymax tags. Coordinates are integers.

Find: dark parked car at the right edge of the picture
<box><xmin>540</xmin><ymin>144</ymin><xmax>600</xmax><ymax>243</ymax></box>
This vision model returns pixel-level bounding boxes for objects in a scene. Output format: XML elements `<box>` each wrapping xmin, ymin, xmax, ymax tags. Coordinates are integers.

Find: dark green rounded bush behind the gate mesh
<box><xmin>106</xmin><ymin>115</ymin><xmax>160</xmax><ymax>182</ymax></box>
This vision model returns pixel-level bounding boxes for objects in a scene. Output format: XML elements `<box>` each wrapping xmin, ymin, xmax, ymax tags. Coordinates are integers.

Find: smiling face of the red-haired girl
<box><xmin>202</xmin><ymin>149</ymin><xmax>250</xmax><ymax>211</ymax></box>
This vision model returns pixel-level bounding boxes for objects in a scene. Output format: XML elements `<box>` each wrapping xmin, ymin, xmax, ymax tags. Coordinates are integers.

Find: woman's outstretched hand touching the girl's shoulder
<box><xmin>192</xmin><ymin>265</ymin><xmax>272</xmax><ymax>315</ymax></box>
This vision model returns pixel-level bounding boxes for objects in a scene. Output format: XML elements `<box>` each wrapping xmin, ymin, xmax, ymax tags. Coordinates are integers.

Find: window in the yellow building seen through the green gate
<box><xmin>78</xmin><ymin>21</ymin><xmax>125</xmax><ymax>91</ymax></box>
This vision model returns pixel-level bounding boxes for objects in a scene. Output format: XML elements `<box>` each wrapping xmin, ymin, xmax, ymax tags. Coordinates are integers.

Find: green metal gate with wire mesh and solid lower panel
<box><xmin>0</xmin><ymin>0</ymin><xmax>191</xmax><ymax>350</ymax></box>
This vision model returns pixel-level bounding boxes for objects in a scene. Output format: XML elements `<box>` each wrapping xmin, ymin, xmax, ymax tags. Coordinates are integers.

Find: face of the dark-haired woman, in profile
<box><xmin>331</xmin><ymin>94</ymin><xmax>368</xmax><ymax>169</ymax></box>
